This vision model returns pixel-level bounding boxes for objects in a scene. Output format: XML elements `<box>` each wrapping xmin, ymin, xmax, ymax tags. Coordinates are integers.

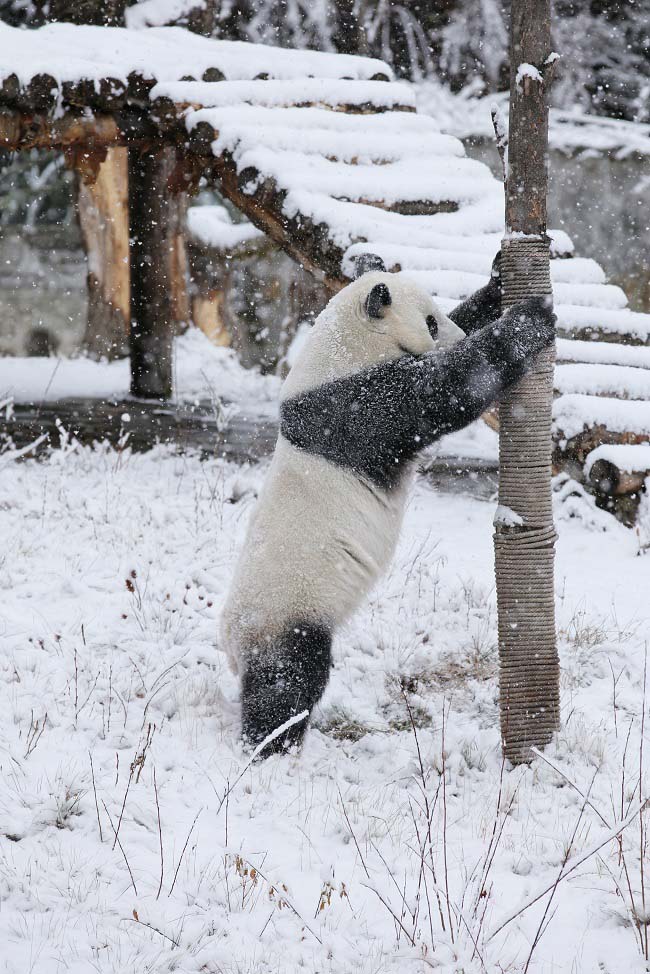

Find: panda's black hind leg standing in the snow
<box><xmin>242</xmin><ymin>622</ymin><xmax>332</xmax><ymax>757</ymax></box>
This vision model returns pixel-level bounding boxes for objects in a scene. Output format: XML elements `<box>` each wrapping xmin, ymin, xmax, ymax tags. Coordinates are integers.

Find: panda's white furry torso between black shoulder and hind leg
<box><xmin>221</xmin><ymin>436</ymin><xmax>409</xmax><ymax>669</ymax></box>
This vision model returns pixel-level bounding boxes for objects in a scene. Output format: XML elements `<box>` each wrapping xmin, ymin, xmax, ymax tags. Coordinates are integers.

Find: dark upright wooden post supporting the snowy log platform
<box><xmin>128</xmin><ymin>148</ymin><xmax>174</xmax><ymax>399</ymax></box>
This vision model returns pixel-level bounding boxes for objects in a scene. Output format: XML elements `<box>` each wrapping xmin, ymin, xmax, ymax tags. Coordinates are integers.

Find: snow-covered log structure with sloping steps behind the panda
<box><xmin>0</xmin><ymin>24</ymin><xmax>650</xmax><ymax>510</ymax></box>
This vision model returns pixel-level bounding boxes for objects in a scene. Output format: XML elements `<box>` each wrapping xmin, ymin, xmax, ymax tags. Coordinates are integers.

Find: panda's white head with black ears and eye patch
<box><xmin>282</xmin><ymin>254</ymin><xmax>465</xmax><ymax>399</ymax></box>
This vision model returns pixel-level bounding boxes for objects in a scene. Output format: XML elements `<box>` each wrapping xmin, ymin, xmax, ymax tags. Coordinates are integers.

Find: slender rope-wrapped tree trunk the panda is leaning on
<box><xmin>495</xmin><ymin>0</ymin><xmax>559</xmax><ymax>763</ymax></box>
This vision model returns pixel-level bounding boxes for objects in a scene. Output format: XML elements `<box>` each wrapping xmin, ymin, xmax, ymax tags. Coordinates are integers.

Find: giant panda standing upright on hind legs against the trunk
<box><xmin>220</xmin><ymin>255</ymin><xmax>555</xmax><ymax>753</ymax></box>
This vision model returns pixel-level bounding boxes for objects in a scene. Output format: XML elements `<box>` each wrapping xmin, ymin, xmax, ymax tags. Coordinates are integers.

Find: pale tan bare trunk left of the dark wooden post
<box><xmin>78</xmin><ymin>147</ymin><xmax>130</xmax><ymax>358</ymax></box>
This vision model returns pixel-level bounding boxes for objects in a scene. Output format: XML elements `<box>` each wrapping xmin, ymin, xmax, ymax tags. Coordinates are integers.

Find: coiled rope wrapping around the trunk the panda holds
<box><xmin>494</xmin><ymin>236</ymin><xmax>559</xmax><ymax>763</ymax></box>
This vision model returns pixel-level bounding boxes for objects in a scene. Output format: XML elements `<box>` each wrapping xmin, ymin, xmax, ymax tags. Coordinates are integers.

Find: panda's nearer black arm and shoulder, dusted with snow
<box><xmin>280</xmin><ymin>298</ymin><xmax>555</xmax><ymax>487</ymax></box>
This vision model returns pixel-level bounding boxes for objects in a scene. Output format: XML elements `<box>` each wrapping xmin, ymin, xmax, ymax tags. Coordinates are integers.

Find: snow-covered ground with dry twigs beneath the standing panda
<box><xmin>0</xmin><ymin>443</ymin><xmax>650</xmax><ymax>974</ymax></box>
